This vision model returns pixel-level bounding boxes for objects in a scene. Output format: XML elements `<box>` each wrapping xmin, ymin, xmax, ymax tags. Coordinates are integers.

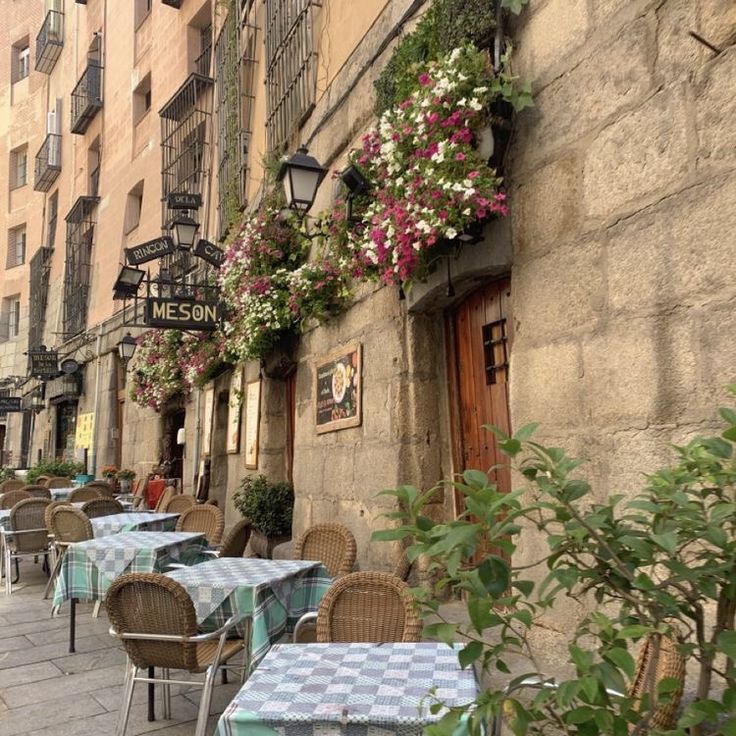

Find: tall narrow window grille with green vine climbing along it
<box><xmin>215</xmin><ymin>12</ymin><xmax>257</xmax><ymax>237</ymax></box>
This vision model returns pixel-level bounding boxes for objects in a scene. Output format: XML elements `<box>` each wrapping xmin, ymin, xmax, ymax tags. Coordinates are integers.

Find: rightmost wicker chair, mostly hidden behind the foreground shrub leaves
<box><xmin>490</xmin><ymin>634</ymin><xmax>685</xmax><ymax>736</ymax></box>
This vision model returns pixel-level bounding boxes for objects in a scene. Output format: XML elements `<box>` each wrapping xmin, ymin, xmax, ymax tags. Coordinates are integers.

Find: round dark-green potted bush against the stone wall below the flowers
<box><xmin>233</xmin><ymin>475</ymin><xmax>294</xmax><ymax>559</ymax></box>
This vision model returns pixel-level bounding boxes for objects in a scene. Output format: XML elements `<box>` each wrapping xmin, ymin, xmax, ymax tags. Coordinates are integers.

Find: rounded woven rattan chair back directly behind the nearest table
<box><xmin>317</xmin><ymin>572</ymin><xmax>422</xmax><ymax>643</ymax></box>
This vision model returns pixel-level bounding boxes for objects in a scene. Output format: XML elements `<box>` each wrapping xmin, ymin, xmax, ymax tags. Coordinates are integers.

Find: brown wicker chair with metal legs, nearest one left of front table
<box><xmin>105</xmin><ymin>573</ymin><xmax>248</xmax><ymax>736</ymax></box>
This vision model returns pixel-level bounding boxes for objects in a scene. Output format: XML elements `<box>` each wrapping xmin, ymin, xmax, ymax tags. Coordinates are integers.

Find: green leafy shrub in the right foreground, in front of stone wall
<box><xmin>374</xmin><ymin>389</ymin><xmax>736</xmax><ymax>736</ymax></box>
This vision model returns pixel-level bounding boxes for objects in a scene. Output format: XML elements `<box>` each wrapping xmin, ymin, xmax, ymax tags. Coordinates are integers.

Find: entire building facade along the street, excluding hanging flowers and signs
<box><xmin>0</xmin><ymin>0</ymin><xmax>736</xmax><ymax>568</ymax></box>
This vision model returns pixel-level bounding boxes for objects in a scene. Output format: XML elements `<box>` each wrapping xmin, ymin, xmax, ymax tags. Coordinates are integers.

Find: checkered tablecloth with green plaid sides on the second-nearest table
<box><xmin>167</xmin><ymin>557</ymin><xmax>332</xmax><ymax>662</ymax></box>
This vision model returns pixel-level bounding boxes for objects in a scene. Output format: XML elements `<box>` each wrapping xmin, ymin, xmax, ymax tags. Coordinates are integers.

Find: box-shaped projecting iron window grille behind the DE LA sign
<box><xmin>159</xmin><ymin>72</ymin><xmax>213</xmax><ymax>280</ymax></box>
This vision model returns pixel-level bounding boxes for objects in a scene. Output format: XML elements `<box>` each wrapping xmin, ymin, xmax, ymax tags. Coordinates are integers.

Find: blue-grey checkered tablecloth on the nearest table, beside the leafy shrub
<box><xmin>217</xmin><ymin>642</ymin><xmax>478</xmax><ymax>736</ymax></box>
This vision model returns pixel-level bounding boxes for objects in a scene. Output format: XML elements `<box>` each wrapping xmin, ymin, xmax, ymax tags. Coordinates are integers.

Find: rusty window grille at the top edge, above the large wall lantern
<box><xmin>265</xmin><ymin>0</ymin><xmax>322</xmax><ymax>151</ymax></box>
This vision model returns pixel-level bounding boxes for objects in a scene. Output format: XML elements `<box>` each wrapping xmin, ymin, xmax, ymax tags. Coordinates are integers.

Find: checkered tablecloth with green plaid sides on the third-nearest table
<box><xmin>53</xmin><ymin>532</ymin><xmax>207</xmax><ymax>607</ymax></box>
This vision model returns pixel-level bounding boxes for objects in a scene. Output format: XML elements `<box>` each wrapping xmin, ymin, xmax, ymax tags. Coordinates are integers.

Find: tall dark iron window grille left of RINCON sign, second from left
<box><xmin>63</xmin><ymin>197</ymin><xmax>100</xmax><ymax>339</ymax></box>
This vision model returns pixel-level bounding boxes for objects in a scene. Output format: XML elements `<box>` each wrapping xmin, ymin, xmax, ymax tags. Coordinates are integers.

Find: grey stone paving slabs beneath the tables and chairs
<box><xmin>0</xmin><ymin>560</ymin><xmax>239</xmax><ymax>736</ymax></box>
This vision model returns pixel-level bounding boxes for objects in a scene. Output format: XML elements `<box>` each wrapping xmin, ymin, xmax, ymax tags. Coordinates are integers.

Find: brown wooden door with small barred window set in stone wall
<box><xmin>448</xmin><ymin>278</ymin><xmax>512</xmax><ymax>514</ymax></box>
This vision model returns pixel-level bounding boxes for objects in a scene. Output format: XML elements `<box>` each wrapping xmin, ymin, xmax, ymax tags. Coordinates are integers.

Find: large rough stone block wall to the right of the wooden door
<box><xmin>509</xmin><ymin>0</ymin><xmax>736</xmax><ymax>558</ymax></box>
